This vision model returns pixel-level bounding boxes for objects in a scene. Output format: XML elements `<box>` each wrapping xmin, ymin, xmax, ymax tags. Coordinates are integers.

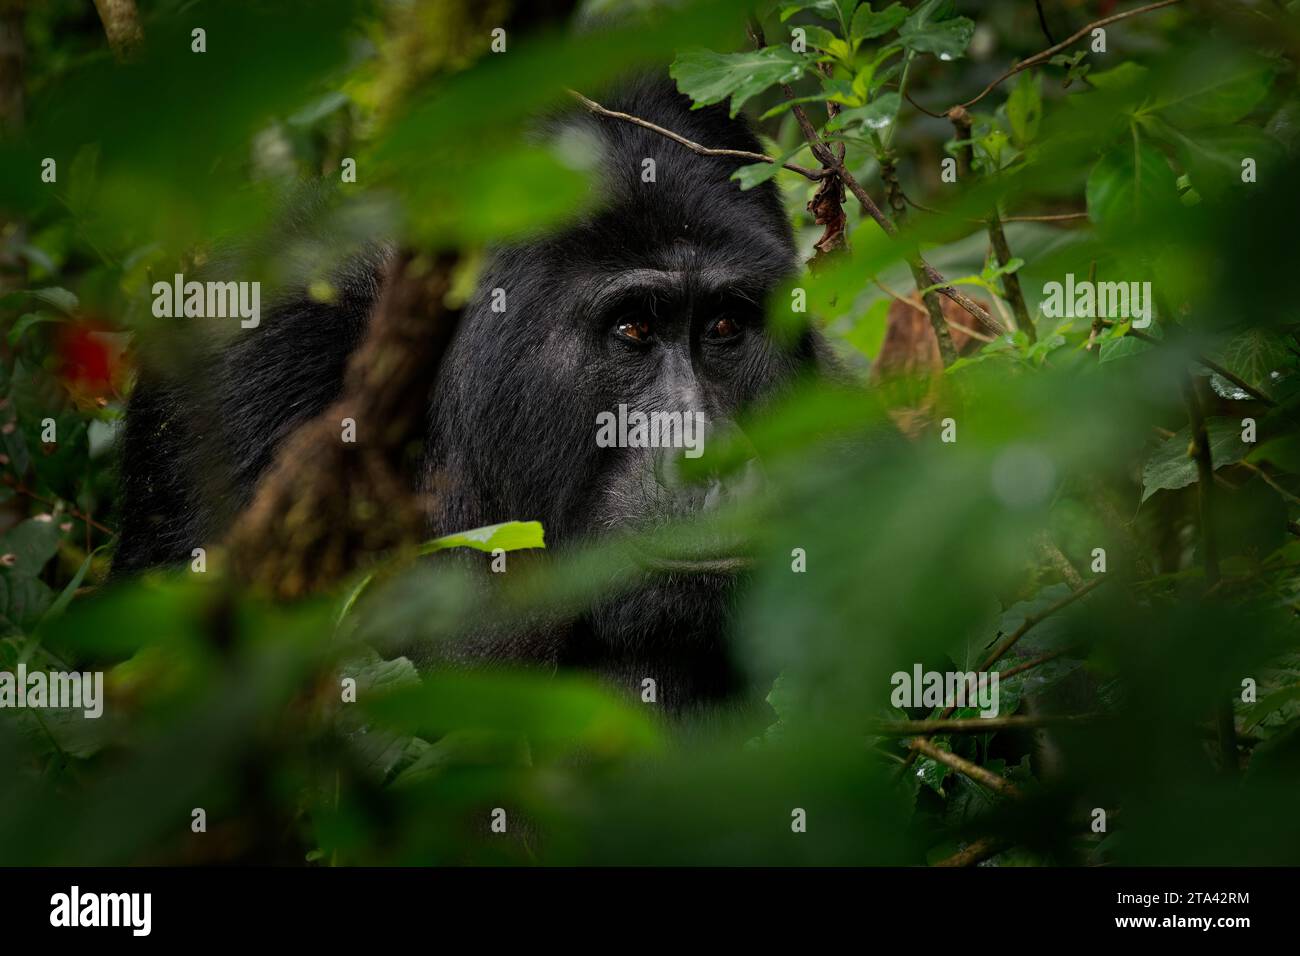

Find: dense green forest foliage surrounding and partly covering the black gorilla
<box><xmin>0</xmin><ymin>0</ymin><xmax>1300</xmax><ymax>865</ymax></box>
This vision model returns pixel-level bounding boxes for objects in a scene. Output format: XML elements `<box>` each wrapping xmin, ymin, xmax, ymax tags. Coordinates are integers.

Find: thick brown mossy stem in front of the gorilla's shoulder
<box><xmin>226</xmin><ymin>252</ymin><xmax>459</xmax><ymax>598</ymax></box>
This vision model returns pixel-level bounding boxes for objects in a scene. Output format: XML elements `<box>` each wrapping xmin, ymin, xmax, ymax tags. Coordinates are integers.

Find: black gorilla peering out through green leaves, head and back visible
<box><xmin>114</xmin><ymin>77</ymin><xmax>831</xmax><ymax>710</ymax></box>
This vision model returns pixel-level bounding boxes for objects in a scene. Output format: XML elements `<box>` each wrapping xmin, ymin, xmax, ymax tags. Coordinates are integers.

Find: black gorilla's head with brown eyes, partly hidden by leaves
<box><xmin>429</xmin><ymin>83</ymin><xmax>823</xmax><ymax>701</ymax></box>
